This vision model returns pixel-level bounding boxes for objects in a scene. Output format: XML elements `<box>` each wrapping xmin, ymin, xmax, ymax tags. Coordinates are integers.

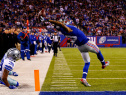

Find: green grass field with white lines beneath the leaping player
<box><xmin>41</xmin><ymin>48</ymin><xmax>126</xmax><ymax>91</ymax></box>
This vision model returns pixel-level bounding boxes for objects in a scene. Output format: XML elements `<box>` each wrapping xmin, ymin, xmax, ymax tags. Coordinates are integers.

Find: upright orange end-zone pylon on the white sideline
<box><xmin>34</xmin><ymin>70</ymin><xmax>40</xmax><ymax>91</ymax></box>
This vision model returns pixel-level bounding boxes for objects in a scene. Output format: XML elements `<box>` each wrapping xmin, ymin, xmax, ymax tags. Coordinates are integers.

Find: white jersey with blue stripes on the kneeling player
<box><xmin>0</xmin><ymin>54</ymin><xmax>15</xmax><ymax>78</ymax></box>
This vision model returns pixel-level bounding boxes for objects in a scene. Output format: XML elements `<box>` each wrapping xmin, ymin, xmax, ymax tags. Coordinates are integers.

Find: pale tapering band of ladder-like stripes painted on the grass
<box><xmin>50</xmin><ymin>52</ymin><xmax>78</xmax><ymax>89</ymax></box>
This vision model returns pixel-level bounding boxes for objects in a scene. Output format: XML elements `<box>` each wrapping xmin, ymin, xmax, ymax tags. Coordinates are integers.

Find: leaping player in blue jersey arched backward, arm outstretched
<box><xmin>41</xmin><ymin>17</ymin><xmax>109</xmax><ymax>86</ymax></box>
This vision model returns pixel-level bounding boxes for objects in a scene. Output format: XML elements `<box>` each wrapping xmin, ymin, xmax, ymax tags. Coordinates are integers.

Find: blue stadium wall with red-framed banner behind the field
<box><xmin>60</xmin><ymin>34</ymin><xmax>126</xmax><ymax>47</ymax></box>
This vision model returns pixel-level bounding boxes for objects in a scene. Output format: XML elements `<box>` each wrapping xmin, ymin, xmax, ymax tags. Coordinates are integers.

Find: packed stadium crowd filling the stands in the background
<box><xmin>0</xmin><ymin>0</ymin><xmax>126</xmax><ymax>57</ymax></box>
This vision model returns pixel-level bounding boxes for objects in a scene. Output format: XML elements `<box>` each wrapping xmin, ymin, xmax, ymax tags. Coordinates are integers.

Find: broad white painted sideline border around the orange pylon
<box><xmin>0</xmin><ymin>52</ymin><xmax>53</xmax><ymax>95</ymax></box>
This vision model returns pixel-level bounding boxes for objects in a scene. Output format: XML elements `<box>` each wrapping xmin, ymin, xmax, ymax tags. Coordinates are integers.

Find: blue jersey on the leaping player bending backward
<box><xmin>60</xmin><ymin>25</ymin><xmax>89</xmax><ymax>46</ymax></box>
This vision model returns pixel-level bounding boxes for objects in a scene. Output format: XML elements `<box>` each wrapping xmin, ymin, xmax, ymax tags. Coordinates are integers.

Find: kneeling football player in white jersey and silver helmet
<box><xmin>0</xmin><ymin>48</ymin><xmax>20</xmax><ymax>89</ymax></box>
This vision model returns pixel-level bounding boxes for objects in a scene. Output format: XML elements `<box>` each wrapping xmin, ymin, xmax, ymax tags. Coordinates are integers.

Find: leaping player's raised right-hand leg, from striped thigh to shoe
<box><xmin>85</xmin><ymin>41</ymin><xmax>109</xmax><ymax>69</ymax></box>
